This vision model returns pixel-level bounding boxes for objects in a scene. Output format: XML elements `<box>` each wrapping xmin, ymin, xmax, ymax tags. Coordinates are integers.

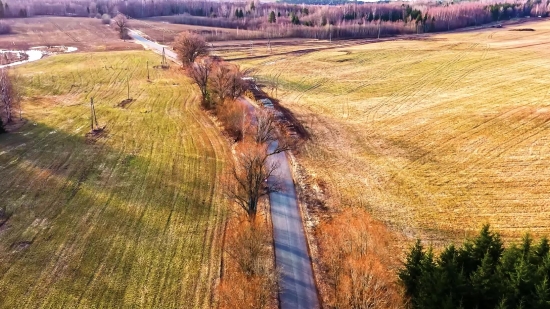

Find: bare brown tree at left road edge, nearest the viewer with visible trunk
<box><xmin>225</xmin><ymin>142</ymin><xmax>279</xmax><ymax>221</ymax></box>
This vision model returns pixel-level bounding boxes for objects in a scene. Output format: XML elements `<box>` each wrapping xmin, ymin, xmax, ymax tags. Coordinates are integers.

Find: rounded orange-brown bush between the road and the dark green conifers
<box><xmin>317</xmin><ymin>209</ymin><xmax>403</xmax><ymax>309</ymax></box>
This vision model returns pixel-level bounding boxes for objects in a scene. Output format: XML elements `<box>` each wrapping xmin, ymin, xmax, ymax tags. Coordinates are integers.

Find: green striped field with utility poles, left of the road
<box><xmin>0</xmin><ymin>51</ymin><xmax>229</xmax><ymax>308</ymax></box>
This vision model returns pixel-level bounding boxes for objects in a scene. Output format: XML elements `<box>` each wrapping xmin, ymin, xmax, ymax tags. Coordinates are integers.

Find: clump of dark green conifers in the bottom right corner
<box><xmin>399</xmin><ymin>226</ymin><xmax>550</xmax><ymax>309</ymax></box>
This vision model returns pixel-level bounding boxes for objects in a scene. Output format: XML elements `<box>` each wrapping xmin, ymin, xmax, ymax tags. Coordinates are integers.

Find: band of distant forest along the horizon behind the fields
<box><xmin>0</xmin><ymin>0</ymin><xmax>550</xmax><ymax>39</ymax></box>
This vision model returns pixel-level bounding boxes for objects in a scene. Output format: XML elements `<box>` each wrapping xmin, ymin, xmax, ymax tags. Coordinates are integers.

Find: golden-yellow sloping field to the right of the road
<box><xmin>240</xmin><ymin>21</ymin><xmax>550</xmax><ymax>241</ymax></box>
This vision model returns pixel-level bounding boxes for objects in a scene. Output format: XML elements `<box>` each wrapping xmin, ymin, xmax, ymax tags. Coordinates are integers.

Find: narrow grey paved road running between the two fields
<box><xmin>133</xmin><ymin>30</ymin><xmax>320</xmax><ymax>309</ymax></box>
